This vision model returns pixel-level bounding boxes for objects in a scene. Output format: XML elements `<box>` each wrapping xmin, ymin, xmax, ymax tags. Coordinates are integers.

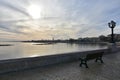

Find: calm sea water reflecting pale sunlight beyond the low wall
<box><xmin>0</xmin><ymin>42</ymin><xmax>107</xmax><ymax>60</ymax></box>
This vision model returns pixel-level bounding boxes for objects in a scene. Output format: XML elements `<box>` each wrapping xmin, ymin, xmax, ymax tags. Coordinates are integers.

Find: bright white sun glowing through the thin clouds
<box><xmin>27</xmin><ymin>5</ymin><xmax>42</xmax><ymax>19</ymax></box>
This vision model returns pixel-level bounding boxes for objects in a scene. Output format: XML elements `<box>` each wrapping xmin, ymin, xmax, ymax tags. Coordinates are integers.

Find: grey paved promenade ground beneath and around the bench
<box><xmin>0</xmin><ymin>52</ymin><xmax>120</xmax><ymax>80</ymax></box>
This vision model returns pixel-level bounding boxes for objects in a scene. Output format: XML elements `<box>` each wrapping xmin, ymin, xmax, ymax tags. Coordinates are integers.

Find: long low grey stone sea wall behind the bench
<box><xmin>0</xmin><ymin>49</ymin><xmax>117</xmax><ymax>74</ymax></box>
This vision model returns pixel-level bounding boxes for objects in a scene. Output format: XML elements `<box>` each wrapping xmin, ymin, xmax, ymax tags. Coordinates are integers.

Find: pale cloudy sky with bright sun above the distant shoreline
<box><xmin>0</xmin><ymin>0</ymin><xmax>120</xmax><ymax>40</ymax></box>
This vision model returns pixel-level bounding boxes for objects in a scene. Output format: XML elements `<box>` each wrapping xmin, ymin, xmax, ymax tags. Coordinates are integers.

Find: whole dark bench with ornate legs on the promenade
<box><xmin>80</xmin><ymin>52</ymin><xmax>104</xmax><ymax>68</ymax></box>
